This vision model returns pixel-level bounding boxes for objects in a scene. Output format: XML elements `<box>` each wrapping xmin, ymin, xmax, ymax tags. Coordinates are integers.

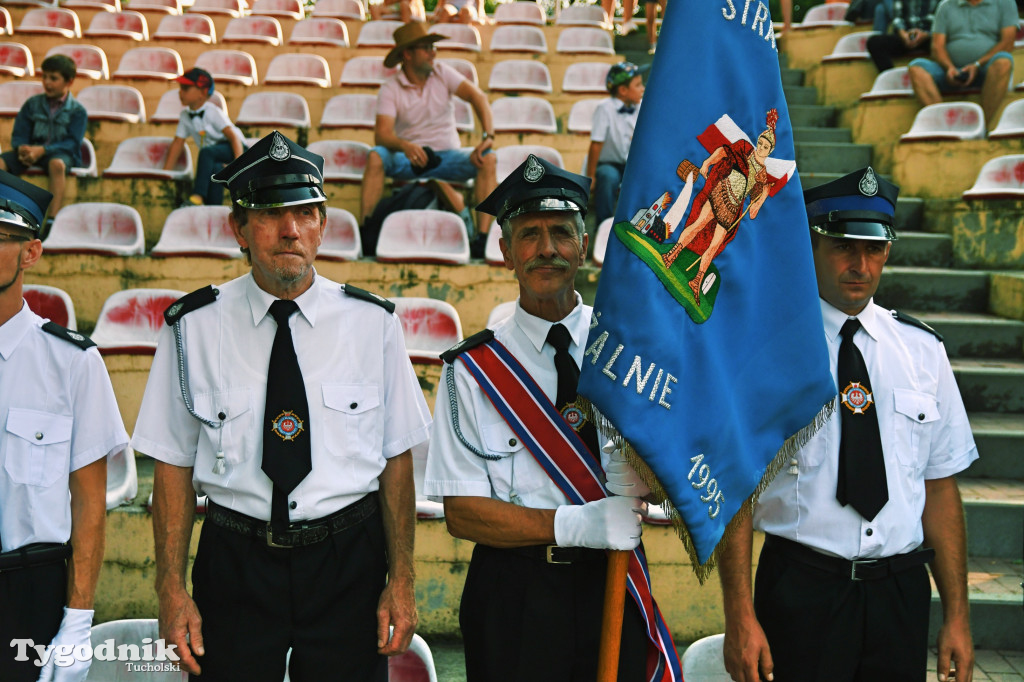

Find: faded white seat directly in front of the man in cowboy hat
<box><xmin>377</xmin><ymin>209</ymin><xmax>469</xmax><ymax>264</ymax></box>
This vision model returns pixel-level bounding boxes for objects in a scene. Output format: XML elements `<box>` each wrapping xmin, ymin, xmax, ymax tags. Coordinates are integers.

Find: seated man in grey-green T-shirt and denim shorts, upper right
<box><xmin>909</xmin><ymin>0</ymin><xmax>1017</xmax><ymax>121</ymax></box>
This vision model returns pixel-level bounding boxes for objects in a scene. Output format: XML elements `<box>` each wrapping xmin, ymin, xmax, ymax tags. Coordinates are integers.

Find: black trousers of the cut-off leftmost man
<box><xmin>0</xmin><ymin>561</ymin><xmax>68</xmax><ymax>682</ymax></box>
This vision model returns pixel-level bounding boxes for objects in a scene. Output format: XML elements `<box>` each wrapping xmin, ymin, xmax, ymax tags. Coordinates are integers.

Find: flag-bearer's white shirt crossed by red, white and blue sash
<box><xmin>424</xmin><ymin>294</ymin><xmax>608</xmax><ymax>509</ymax></box>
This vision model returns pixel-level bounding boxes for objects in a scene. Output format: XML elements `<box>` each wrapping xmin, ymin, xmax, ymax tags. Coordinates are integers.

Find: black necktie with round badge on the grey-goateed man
<box><xmin>262</xmin><ymin>300</ymin><xmax>312</xmax><ymax>522</ymax></box>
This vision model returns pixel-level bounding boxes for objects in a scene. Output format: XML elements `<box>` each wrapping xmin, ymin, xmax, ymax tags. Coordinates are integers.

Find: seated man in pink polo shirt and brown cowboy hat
<box><xmin>361</xmin><ymin>22</ymin><xmax>498</xmax><ymax>257</ymax></box>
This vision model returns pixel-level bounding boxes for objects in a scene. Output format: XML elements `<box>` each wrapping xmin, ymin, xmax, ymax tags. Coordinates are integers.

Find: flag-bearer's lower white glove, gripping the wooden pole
<box><xmin>555</xmin><ymin>497</ymin><xmax>643</xmax><ymax>550</ymax></box>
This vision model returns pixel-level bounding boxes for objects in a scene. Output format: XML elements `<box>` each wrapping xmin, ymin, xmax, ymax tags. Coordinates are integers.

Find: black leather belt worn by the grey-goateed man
<box><xmin>206</xmin><ymin>493</ymin><xmax>377</xmax><ymax>549</ymax></box>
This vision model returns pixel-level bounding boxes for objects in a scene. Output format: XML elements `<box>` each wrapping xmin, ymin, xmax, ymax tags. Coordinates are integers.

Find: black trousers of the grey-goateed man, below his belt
<box><xmin>189</xmin><ymin>499</ymin><xmax>387</xmax><ymax>682</ymax></box>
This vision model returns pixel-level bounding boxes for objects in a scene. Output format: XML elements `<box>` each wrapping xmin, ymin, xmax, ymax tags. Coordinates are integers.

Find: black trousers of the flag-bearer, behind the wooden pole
<box><xmin>459</xmin><ymin>545</ymin><xmax>647</xmax><ymax>682</ymax></box>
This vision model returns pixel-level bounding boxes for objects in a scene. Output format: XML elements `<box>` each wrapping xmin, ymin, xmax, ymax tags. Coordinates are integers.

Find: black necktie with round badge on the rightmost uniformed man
<box><xmin>836</xmin><ymin>317</ymin><xmax>889</xmax><ymax>521</ymax></box>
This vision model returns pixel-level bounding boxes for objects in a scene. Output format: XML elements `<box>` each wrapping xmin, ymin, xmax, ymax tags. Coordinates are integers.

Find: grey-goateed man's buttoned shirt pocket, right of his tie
<box><xmin>323</xmin><ymin>384</ymin><xmax>384</xmax><ymax>457</ymax></box>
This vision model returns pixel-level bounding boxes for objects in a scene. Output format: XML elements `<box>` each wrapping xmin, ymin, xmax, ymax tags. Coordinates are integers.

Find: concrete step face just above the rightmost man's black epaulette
<box><xmin>872</xmin><ymin>266</ymin><xmax>989</xmax><ymax>312</ymax></box>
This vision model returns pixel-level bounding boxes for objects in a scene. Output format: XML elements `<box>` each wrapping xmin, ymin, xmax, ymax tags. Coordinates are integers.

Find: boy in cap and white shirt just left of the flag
<box><xmin>587</xmin><ymin>61</ymin><xmax>644</xmax><ymax>225</ymax></box>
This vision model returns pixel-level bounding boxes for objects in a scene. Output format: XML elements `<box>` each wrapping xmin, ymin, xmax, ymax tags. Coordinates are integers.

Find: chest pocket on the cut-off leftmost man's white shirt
<box><xmin>3</xmin><ymin>408</ymin><xmax>75</xmax><ymax>487</ymax></box>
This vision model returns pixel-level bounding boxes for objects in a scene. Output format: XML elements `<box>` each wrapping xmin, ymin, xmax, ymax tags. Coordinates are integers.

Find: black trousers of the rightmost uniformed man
<box><xmin>754</xmin><ymin>532</ymin><xmax>932</xmax><ymax>682</ymax></box>
